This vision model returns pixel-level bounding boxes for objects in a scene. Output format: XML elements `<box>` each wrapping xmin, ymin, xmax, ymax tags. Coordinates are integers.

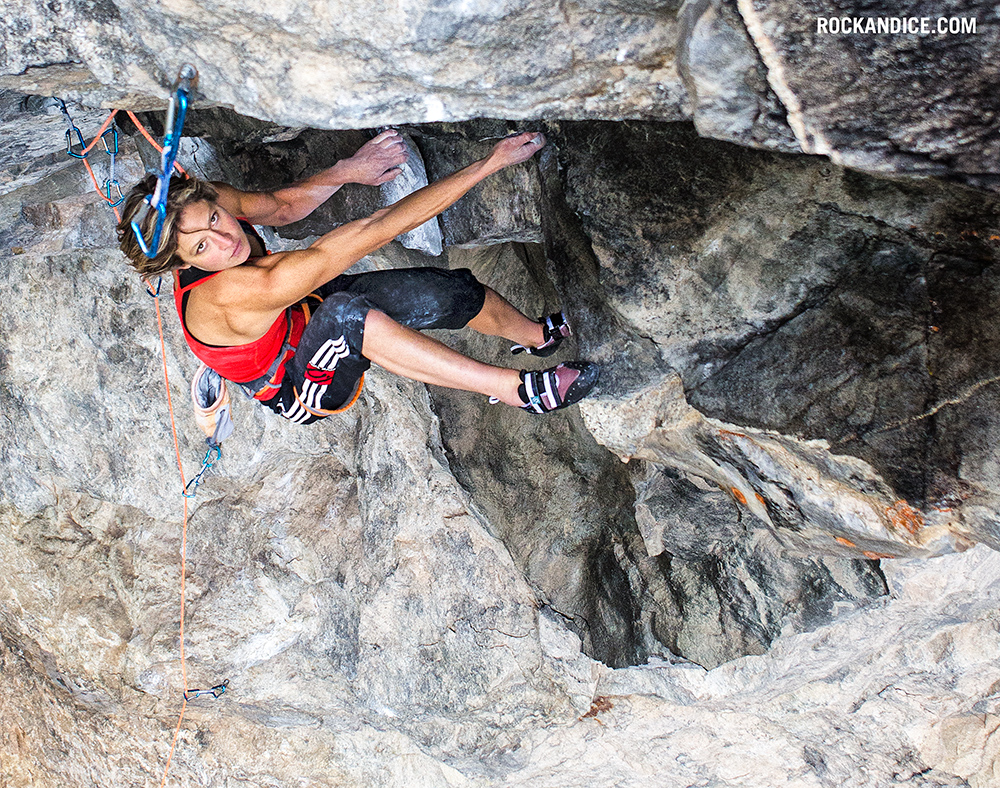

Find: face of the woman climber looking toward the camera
<box><xmin>177</xmin><ymin>200</ymin><xmax>250</xmax><ymax>271</ymax></box>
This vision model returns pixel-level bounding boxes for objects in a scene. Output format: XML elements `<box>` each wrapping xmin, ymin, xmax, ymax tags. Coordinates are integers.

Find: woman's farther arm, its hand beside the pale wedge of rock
<box><xmin>212</xmin><ymin>129</ymin><xmax>409</xmax><ymax>227</ymax></box>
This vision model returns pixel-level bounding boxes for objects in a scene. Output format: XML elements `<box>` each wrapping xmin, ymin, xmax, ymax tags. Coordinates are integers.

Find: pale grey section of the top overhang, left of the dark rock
<box><xmin>0</xmin><ymin>0</ymin><xmax>685</xmax><ymax>128</ymax></box>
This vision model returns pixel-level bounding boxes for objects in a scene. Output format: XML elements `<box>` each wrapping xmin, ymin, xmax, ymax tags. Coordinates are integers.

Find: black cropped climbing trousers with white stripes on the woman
<box><xmin>264</xmin><ymin>268</ymin><xmax>486</xmax><ymax>424</ymax></box>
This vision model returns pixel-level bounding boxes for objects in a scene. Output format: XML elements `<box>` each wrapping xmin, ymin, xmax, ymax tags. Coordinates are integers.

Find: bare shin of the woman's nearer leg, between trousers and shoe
<box><xmin>361</xmin><ymin>307</ymin><xmax>528</xmax><ymax>406</ymax></box>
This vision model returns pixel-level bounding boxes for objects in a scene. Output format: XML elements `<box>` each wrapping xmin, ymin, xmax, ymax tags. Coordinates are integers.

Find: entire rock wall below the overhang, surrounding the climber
<box><xmin>0</xmin><ymin>104</ymin><xmax>1000</xmax><ymax>788</ymax></box>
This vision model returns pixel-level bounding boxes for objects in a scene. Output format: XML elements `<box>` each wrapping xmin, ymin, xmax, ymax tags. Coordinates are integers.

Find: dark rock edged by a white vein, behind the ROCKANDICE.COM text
<box><xmin>737</xmin><ymin>0</ymin><xmax>1000</xmax><ymax>180</ymax></box>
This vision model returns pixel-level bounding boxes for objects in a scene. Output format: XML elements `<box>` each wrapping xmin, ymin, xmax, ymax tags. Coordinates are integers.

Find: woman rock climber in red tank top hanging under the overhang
<box><xmin>118</xmin><ymin>130</ymin><xmax>598</xmax><ymax>424</ymax></box>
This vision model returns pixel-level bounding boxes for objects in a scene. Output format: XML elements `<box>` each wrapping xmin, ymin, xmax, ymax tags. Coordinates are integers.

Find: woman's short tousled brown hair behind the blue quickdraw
<box><xmin>118</xmin><ymin>173</ymin><xmax>219</xmax><ymax>279</ymax></box>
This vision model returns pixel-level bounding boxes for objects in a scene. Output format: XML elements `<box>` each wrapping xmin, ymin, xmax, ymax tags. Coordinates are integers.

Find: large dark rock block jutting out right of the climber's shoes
<box><xmin>556</xmin><ymin>124</ymin><xmax>1000</xmax><ymax>554</ymax></box>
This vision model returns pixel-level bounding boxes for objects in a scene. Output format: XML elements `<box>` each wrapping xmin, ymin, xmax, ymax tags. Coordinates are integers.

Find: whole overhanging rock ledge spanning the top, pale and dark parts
<box><xmin>0</xmin><ymin>0</ymin><xmax>1000</xmax><ymax>182</ymax></box>
